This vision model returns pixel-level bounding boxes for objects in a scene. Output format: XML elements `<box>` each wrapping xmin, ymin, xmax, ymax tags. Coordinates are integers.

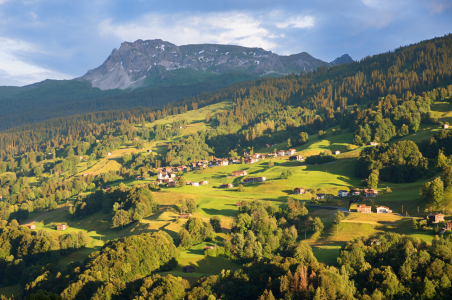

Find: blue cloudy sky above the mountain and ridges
<box><xmin>0</xmin><ymin>0</ymin><xmax>452</xmax><ymax>86</ymax></box>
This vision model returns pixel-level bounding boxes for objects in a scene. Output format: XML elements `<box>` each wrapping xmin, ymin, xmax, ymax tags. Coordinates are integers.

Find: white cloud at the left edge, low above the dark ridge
<box><xmin>0</xmin><ymin>37</ymin><xmax>73</xmax><ymax>86</ymax></box>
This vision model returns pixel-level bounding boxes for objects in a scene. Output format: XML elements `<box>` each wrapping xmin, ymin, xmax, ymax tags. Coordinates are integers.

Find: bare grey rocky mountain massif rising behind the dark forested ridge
<box><xmin>78</xmin><ymin>39</ymin><xmax>353</xmax><ymax>90</ymax></box>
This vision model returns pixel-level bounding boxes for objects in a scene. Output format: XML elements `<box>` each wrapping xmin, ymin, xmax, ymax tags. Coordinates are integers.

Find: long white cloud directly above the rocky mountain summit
<box><xmin>98</xmin><ymin>11</ymin><xmax>314</xmax><ymax>50</ymax></box>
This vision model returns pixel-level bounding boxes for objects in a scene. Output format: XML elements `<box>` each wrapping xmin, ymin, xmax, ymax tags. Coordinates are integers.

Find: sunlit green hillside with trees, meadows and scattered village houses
<box><xmin>0</xmin><ymin>35</ymin><xmax>452</xmax><ymax>300</ymax></box>
